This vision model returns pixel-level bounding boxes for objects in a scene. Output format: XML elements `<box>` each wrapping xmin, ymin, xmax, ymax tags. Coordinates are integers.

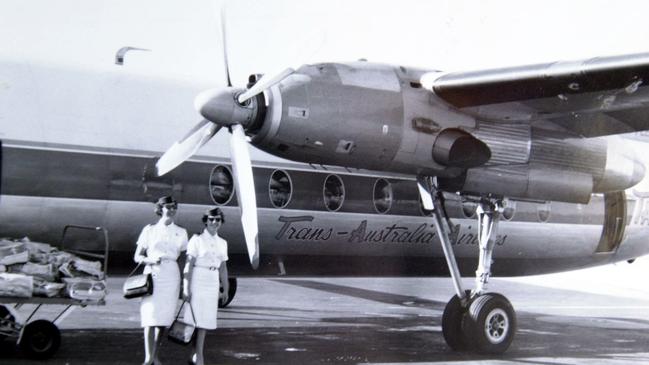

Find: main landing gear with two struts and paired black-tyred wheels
<box><xmin>417</xmin><ymin>177</ymin><xmax>516</xmax><ymax>354</ymax></box>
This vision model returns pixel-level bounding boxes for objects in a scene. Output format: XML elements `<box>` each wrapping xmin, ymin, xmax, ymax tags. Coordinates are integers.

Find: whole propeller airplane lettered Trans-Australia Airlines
<box><xmin>0</xmin><ymin>1</ymin><xmax>649</xmax><ymax>353</ymax></box>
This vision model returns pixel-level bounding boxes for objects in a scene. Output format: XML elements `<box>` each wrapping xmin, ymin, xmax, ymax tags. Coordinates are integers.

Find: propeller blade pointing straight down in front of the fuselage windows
<box><xmin>230</xmin><ymin>124</ymin><xmax>259</xmax><ymax>269</ymax></box>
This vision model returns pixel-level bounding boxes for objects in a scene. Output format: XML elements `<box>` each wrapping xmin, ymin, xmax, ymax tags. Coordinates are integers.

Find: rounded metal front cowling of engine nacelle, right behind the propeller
<box><xmin>252</xmin><ymin>62</ymin><xmax>480</xmax><ymax>176</ymax></box>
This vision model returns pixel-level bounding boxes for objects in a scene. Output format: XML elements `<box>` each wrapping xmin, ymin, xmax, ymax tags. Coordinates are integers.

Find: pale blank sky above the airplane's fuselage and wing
<box><xmin>0</xmin><ymin>0</ymin><xmax>649</xmax><ymax>84</ymax></box>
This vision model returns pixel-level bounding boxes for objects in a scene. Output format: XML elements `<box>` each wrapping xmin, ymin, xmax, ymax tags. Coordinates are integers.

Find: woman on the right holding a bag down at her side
<box><xmin>183</xmin><ymin>208</ymin><xmax>229</xmax><ymax>365</ymax></box>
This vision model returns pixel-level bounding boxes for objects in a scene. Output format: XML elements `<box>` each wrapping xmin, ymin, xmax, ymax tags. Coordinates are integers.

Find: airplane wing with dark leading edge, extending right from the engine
<box><xmin>421</xmin><ymin>53</ymin><xmax>649</xmax><ymax>137</ymax></box>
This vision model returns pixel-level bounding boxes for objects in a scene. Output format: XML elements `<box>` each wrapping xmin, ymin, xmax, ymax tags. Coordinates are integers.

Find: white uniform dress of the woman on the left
<box><xmin>137</xmin><ymin>221</ymin><xmax>187</xmax><ymax>327</ymax></box>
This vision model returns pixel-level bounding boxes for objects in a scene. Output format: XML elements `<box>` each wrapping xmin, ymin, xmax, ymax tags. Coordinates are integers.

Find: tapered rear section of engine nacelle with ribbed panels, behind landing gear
<box><xmin>439</xmin><ymin>130</ymin><xmax>645</xmax><ymax>204</ymax></box>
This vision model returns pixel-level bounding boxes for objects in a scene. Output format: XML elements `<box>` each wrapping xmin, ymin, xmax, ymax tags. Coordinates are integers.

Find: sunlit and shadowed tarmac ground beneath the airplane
<box><xmin>0</xmin><ymin>259</ymin><xmax>649</xmax><ymax>365</ymax></box>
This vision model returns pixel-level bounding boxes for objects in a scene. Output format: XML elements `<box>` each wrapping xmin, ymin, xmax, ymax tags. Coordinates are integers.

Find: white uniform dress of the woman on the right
<box><xmin>183</xmin><ymin>230</ymin><xmax>228</xmax><ymax>330</ymax></box>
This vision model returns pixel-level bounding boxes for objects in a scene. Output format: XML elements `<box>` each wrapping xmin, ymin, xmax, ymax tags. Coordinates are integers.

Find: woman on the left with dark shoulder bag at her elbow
<box><xmin>134</xmin><ymin>196</ymin><xmax>187</xmax><ymax>364</ymax></box>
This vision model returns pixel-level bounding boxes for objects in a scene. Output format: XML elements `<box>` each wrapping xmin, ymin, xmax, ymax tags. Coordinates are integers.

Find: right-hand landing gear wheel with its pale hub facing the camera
<box><xmin>462</xmin><ymin>293</ymin><xmax>516</xmax><ymax>354</ymax></box>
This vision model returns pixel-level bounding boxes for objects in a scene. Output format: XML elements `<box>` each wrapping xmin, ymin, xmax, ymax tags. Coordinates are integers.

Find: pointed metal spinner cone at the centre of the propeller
<box><xmin>194</xmin><ymin>87</ymin><xmax>255</xmax><ymax>128</ymax></box>
